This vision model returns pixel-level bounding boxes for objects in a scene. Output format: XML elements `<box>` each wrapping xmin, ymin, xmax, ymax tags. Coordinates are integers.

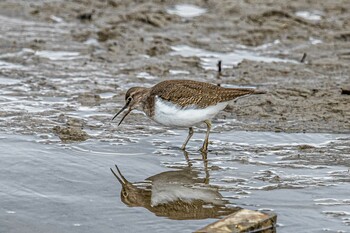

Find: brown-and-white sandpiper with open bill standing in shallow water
<box><xmin>112</xmin><ymin>80</ymin><xmax>265</xmax><ymax>152</ymax></box>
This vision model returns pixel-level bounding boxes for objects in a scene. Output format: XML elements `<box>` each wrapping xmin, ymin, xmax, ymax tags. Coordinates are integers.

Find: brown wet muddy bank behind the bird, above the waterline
<box><xmin>0</xmin><ymin>1</ymin><xmax>350</xmax><ymax>137</ymax></box>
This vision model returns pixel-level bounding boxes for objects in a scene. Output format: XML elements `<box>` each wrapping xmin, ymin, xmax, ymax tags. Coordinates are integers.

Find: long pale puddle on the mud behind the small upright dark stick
<box><xmin>170</xmin><ymin>45</ymin><xmax>297</xmax><ymax>70</ymax></box>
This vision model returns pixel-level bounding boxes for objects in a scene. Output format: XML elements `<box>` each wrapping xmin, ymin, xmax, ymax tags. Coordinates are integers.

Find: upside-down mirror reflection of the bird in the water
<box><xmin>111</xmin><ymin>153</ymin><xmax>240</xmax><ymax>220</ymax></box>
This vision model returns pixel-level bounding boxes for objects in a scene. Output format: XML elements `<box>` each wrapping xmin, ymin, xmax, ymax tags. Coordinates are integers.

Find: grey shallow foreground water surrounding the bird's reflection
<box><xmin>0</xmin><ymin>131</ymin><xmax>350</xmax><ymax>232</ymax></box>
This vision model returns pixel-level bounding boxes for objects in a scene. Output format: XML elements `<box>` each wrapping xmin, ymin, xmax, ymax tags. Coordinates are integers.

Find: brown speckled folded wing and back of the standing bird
<box><xmin>151</xmin><ymin>80</ymin><xmax>255</xmax><ymax>108</ymax></box>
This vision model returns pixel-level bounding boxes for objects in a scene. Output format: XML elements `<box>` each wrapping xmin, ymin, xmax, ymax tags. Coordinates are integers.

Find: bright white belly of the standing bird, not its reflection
<box><xmin>153</xmin><ymin>96</ymin><xmax>228</xmax><ymax>127</ymax></box>
